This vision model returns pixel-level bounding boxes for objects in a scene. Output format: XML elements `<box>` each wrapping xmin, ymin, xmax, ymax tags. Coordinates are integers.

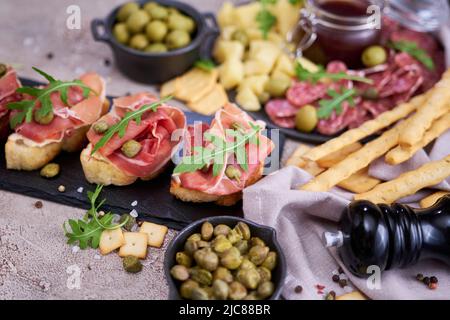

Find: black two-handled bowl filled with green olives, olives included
<box><xmin>91</xmin><ymin>0</ymin><xmax>220</xmax><ymax>84</ymax></box>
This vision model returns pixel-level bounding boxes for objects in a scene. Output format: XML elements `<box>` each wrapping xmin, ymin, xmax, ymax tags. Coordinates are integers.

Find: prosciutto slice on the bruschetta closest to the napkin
<box><xmin>173</xmin><ymin>104</ymin><xmax>274</xmax><ymax>196</ymax></box>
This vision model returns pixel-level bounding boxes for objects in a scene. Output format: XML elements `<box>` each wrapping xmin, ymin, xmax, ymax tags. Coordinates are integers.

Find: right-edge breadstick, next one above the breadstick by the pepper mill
<box><xmin>385</xmin><ymin>113</ymin><xmax>450</xmax><ymax>165</ymax></box>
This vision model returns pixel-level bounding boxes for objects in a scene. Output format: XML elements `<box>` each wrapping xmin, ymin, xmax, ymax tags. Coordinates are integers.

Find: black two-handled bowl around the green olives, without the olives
<box><xmin>91</xmin><ymin>0</ymin><xmax>220</xmax><ymax>84</ymax></box>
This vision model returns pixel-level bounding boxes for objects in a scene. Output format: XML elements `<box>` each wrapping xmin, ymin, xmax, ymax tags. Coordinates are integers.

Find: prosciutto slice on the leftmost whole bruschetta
<box><xmin>13</xmin><ymin>73</ymin><xmax>105</xmax><ymax>143</ymax></box>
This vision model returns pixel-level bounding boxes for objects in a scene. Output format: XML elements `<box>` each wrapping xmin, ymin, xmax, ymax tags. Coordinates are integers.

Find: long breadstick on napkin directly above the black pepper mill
<box><xmin>355</xmin><ymin>155</ymin><xmax>450</xmax><ymax>204</ymax></box>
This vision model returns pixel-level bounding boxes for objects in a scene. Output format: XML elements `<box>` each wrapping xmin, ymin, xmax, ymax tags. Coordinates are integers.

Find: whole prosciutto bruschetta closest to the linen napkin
<box><xmin>170</xmin><ymin>104</ymin><xmax>274</xmax><ymax>206</ymax></box>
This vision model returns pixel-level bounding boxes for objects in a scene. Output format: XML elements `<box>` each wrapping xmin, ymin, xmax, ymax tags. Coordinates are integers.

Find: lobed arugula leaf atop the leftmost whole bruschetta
<box><xmin>7</xmin><ymin>67</ymin><xmax>93</xmax><ymax>129</ymax></box>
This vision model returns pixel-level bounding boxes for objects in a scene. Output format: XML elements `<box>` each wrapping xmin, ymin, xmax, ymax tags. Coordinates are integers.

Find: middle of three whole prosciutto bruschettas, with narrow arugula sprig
<box><xmin>81</xmin><ymin>93</ymin><xmax>186</xmax><ymax>186</ymax></box>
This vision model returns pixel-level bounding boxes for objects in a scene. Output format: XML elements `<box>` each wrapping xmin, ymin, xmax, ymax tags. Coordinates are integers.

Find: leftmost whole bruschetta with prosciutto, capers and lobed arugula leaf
<box><xmin>5</xmin><ymin>69</ymin><xmax>109</xmax><ymax>171</ymax></box>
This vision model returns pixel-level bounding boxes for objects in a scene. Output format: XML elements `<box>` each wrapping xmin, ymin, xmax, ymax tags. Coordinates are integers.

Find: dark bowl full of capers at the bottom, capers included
<box><xmin>164</xmin><ymin>216</ymin><xmax>286</xmax><ymax>300</ymax></box>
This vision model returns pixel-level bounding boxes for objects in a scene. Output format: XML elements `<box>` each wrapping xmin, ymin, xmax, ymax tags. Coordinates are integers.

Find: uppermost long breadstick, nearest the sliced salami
<box><xmin>304</xmin><ymin>94</ymin><xmax>426</xmax><ymax>161</ymax></box>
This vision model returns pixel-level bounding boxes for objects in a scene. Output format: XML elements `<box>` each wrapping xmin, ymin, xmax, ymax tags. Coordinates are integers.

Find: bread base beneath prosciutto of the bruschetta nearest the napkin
<box><xmin>170</xmin><ymin>164</ymin><xmax>264</xmax><ymax>207</ymax></box>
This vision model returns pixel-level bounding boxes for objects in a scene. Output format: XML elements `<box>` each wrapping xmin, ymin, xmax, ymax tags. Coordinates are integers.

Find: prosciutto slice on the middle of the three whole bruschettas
<box><xmin>87</xmin><ymin>93</ymin><xmax>186</xmax><ymax>178</ymax></box>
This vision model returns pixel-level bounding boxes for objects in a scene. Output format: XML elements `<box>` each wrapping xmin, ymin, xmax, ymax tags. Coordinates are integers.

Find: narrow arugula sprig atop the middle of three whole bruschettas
<box><xmin>91</xmin><ymin>96</ymin><xmax>172</xmax><ymax>155</ymax></box>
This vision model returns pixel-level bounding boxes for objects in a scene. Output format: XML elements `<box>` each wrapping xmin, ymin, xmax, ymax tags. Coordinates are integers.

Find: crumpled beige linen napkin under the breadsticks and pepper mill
<box><xmin>244</xmin><ymin>130</ymin><xmax>450</xmax><ymax>299</ymax></box>
